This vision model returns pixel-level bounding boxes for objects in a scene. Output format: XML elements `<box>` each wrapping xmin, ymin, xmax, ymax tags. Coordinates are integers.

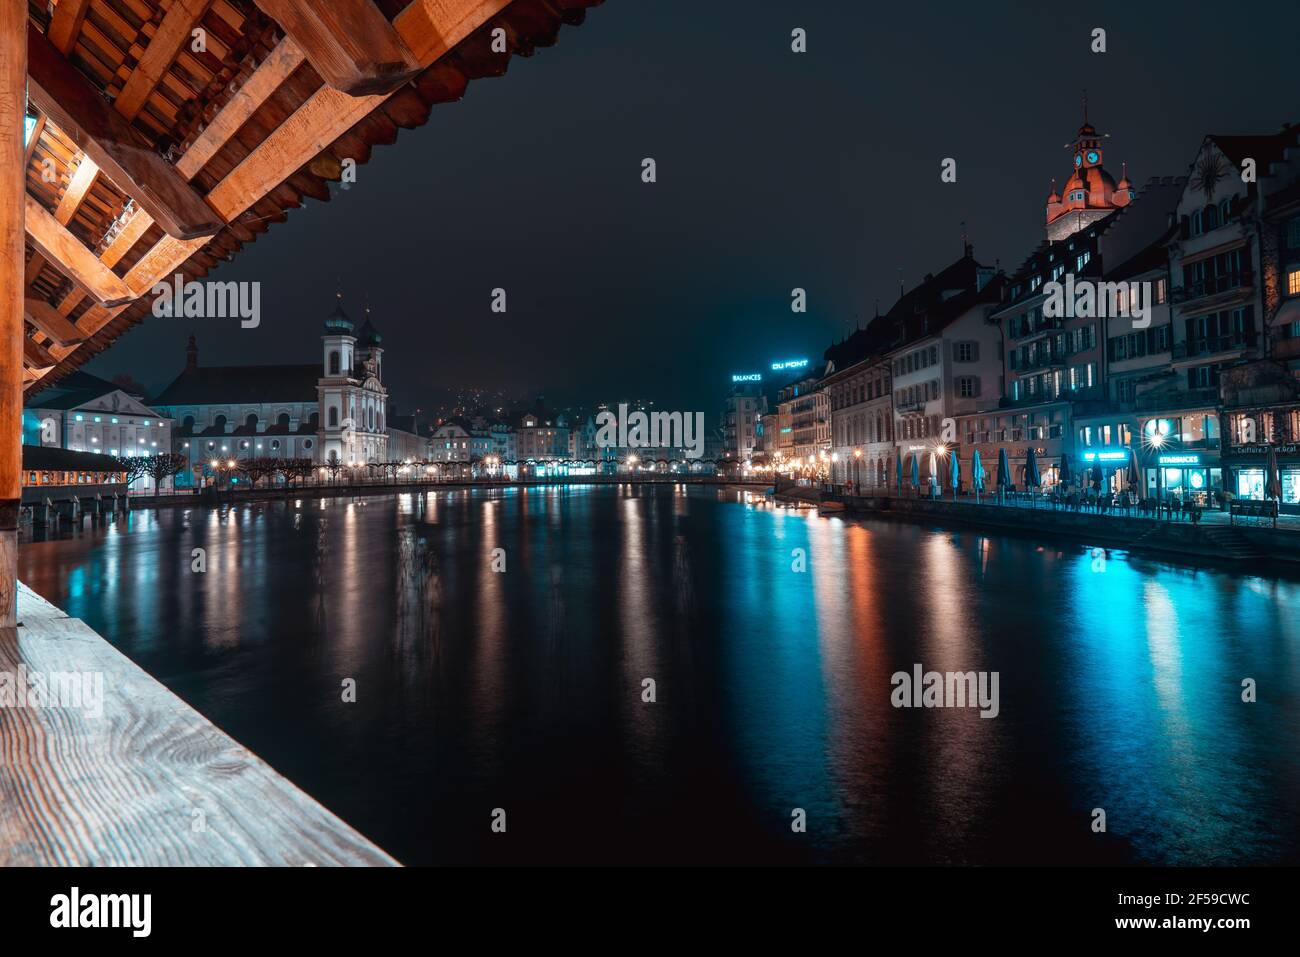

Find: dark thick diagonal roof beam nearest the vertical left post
<box><xmin>27</xmin><ymin>25</ymin><xmax>224</xmax><ymax>239</ymax></box>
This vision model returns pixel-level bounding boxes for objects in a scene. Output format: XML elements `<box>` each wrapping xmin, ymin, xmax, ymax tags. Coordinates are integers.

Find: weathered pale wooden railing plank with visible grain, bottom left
<box><xmin>0</xmin><ymin>585</ymin><xmax>397</xmax><ymax>867</ymax></box>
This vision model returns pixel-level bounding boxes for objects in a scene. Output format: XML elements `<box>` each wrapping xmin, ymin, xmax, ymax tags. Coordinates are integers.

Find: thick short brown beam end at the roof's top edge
<box><xmin>255</xmin><ymin>0</ymin><xmax>421</xmax><ymax>96</ymax></box>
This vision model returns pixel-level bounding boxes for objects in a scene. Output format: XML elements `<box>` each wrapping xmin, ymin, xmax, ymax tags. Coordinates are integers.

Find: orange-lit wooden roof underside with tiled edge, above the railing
<box><xmin>23</xmin><ymin>0</ymin><xmax>602</xmax><ymax>393</ymax></box>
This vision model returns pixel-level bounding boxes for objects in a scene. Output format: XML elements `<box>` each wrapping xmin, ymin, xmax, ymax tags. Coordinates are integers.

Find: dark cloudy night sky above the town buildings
<box><xmin>88</xmin><ymin>0</ymin><xmax>1300</xmax><ymax>410</ymax></box>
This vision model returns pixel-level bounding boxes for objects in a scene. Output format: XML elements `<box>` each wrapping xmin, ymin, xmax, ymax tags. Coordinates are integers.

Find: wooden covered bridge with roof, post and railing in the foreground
<box><xmin>0</xmin><ymin>0</ymin><xmax>601</xmax><ymax>865</ymax></box>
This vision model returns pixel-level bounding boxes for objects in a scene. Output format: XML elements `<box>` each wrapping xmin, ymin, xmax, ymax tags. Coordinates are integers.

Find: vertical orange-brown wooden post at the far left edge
<box><xmin>0</xmin><ymin>3</ymin><xmax>27</xmax><ymax>628</ymax></box>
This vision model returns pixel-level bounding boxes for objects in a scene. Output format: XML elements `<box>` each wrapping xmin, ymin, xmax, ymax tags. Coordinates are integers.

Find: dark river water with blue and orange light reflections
<box><xmin>20</xmin><ymin>486</ymin><xmax>1300</xmax><ymax>863</ymax></box>
